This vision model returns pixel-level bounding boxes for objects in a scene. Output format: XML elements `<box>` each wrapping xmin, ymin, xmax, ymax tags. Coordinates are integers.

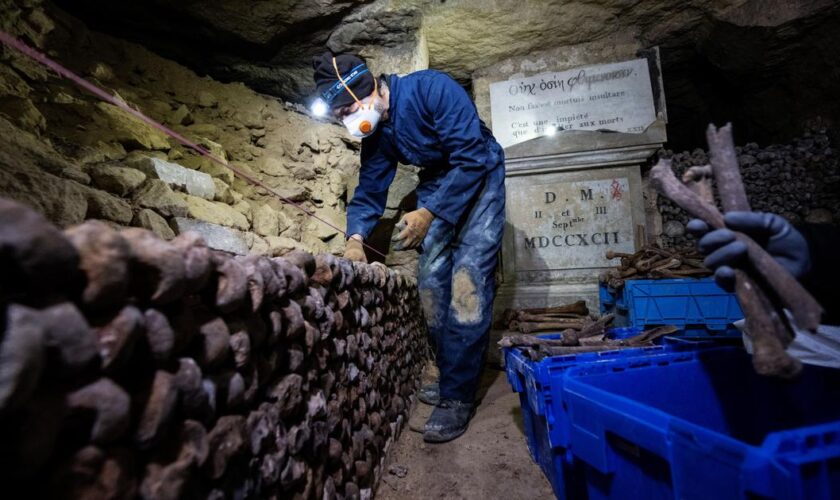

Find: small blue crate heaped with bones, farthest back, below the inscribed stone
<box><xmin>599</xmin><ymin>277</ymin><xmax>744</xmax><ymax>337</ymax></box>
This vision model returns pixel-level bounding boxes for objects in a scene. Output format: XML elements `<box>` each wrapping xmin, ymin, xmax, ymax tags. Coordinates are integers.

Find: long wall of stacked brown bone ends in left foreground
<box><xmin>0</xmin><ymin>199</ymin><xmax>427</xmax><ymax>499</ymax></box>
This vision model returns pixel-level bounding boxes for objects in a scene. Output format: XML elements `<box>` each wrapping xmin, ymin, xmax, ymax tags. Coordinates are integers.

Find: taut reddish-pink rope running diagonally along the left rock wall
<box><xmin>0</xmin><ymin>30</ymin><xmax>385</xmax><ymax>258</ymax></box>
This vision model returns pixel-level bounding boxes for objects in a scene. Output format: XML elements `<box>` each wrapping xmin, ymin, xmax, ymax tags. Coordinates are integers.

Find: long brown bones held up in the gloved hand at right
<box><xmin>650</xmin><ymin>125</ymin><xmax>823</xmax><ymax>378</ymax></box>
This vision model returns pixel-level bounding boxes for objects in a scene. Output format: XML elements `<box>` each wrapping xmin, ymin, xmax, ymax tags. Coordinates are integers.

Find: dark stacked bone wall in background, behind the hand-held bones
<box><xmin>657</xmin><ymin>128</ymin><xmax>840</xmax><ymax>248</ymax></box>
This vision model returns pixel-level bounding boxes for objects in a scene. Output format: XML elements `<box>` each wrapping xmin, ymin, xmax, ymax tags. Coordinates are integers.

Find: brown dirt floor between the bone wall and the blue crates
<box><xmin>376</xmin><ymin>368</ymin><xmax>554</xmax><ymax>500</ymax></box>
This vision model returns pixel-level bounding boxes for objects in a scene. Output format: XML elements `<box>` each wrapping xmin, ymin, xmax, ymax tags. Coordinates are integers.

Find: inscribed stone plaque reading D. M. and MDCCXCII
<box><xmin>503</xmin><ymin>166</ymin><xmax>644</xmax><ymax>282</ymax></box>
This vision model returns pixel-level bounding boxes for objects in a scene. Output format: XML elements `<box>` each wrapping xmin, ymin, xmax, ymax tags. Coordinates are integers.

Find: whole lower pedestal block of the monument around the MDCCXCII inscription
<box><xmin>495</xmin><ymin>164</ymin><xmax>645</xmax><ymax>311</ymax></box>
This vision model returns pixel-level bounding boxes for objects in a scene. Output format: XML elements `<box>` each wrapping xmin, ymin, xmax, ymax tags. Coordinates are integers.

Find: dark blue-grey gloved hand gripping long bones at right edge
<box><xmin>686</xmin><ymin>212</ymin><xmax>811</xmax><ymax>291</ymax></box>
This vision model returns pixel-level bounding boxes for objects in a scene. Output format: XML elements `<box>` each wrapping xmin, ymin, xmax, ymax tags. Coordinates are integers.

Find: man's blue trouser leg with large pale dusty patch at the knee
<box><xmin>418</xmin><ymin>165</ymin><xmax>505</xmax><ymax>402</ymax></box>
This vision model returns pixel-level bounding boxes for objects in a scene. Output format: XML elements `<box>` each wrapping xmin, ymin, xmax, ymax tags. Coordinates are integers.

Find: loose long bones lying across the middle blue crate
<box><xmin>499</xmin><ymin>314</ymin><xmax>677</xmax><ymax>361</ymax></box>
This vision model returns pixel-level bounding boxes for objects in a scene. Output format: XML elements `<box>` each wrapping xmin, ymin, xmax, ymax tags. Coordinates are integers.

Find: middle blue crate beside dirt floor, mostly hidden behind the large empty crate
<box><xmin>504</xmin><ymin>334</ymin><xmax>716</xmax><ymax>499</ymax></box>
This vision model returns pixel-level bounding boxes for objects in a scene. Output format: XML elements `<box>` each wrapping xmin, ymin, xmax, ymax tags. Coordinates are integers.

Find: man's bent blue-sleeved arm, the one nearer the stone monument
<box><xmin>425</xmin><ymin>74</ymin><xmax>488</xmax><ymax>224</ymax></box>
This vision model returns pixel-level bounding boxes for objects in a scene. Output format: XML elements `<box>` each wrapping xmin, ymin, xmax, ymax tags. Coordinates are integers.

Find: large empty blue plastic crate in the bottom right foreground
<box><xmin>563</xmin><ymin>348</ymin><xmax>840</xmax><ymax>500</ymax></box>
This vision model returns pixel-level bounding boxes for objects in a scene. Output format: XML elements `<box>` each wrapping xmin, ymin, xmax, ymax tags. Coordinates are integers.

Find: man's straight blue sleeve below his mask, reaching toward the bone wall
<box><xmin>347</xmin><ymin>142</ymin><xmax>397</xmax><ymax>239</ymax></box>
